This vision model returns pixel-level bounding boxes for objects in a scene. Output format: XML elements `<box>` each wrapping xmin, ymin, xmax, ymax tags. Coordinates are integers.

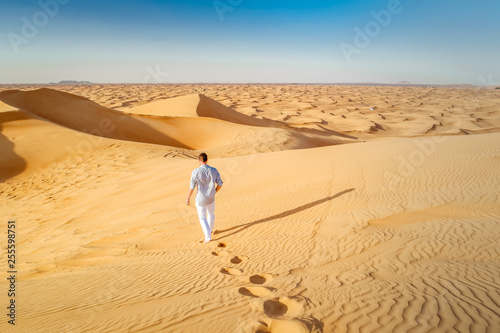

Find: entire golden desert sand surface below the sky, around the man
<box><xmin>0</xmin><ymin>85</ymin><xmax>500</xmax><ymax>333</ymax></box>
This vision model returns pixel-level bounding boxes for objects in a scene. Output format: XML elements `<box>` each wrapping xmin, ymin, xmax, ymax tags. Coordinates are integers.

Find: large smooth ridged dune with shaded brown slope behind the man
<box><xmin>0</xmin><ymin>88</ymin><xmax>340</xmax><ymax>159</ymax></box>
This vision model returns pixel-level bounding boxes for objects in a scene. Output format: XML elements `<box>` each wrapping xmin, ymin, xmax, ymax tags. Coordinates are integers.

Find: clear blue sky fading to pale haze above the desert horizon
<box><xmin>0</xmin><ymin>0</ymin><xmax>500</xmax><ymax>85</ymax></box>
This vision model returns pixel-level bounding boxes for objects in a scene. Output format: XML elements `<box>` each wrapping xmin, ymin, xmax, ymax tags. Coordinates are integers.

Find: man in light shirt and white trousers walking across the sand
<box><xmin>186</xmin><ymin>153</ymin><xmax>222</xmax><ymax>243</ymax></box>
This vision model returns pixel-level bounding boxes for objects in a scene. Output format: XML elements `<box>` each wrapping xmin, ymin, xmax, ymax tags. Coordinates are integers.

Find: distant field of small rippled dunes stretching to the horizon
<box><xmin>33</xmin><ymin>85</ymin><xmax>500</xmax><ymax>140</ymax></box>
